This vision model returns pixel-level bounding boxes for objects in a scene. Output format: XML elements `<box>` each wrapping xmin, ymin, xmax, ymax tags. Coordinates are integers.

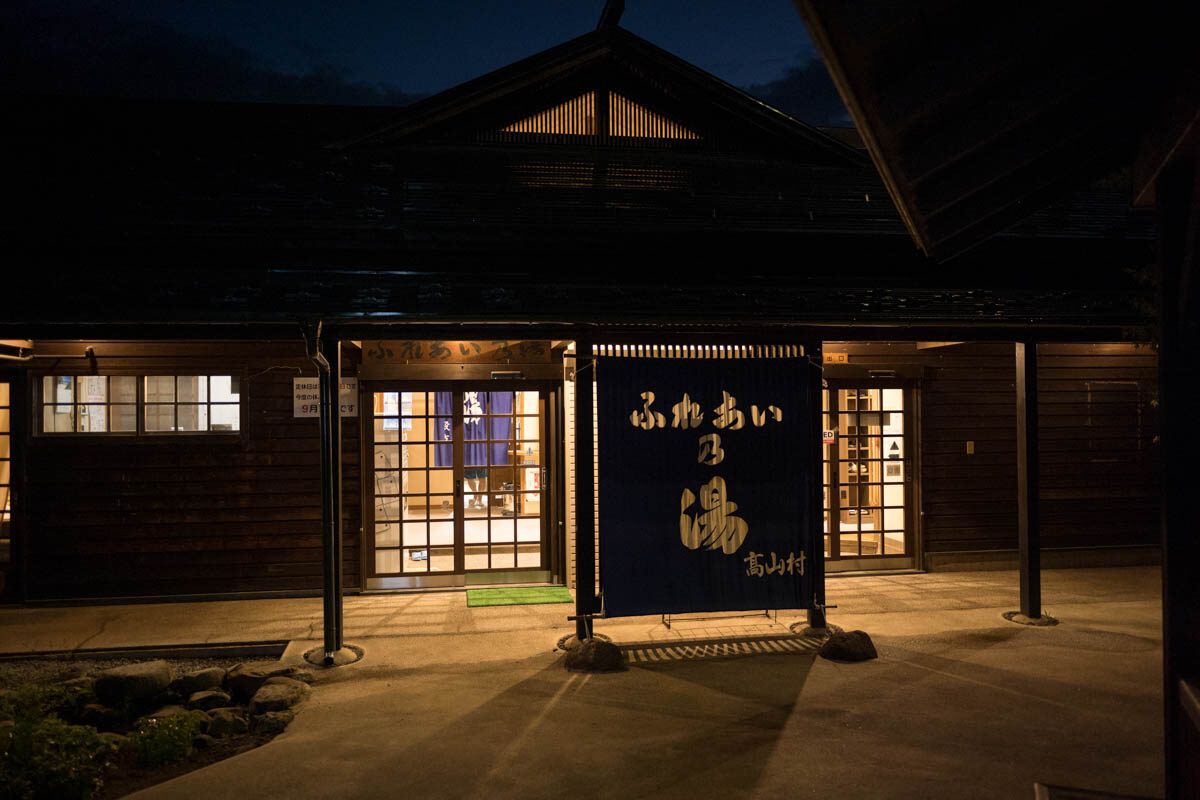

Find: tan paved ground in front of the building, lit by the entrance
<box><xmin>0</xmin><ymin>567</ymin><xmax>1162</xmax><ymax>800</ymax></box>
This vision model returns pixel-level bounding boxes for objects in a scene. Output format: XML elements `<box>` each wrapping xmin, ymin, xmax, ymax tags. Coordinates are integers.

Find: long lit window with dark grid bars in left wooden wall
<box><xmin>41</xmin><ymin>375</ymin><xmax>241</xmax><ymax>434</ymax></box>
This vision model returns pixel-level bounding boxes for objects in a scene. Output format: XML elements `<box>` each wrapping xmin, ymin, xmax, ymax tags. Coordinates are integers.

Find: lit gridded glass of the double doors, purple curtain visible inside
<box><xmin>371</xmin><ymin>386</ymin><xmax>545</xmax><ymax>577</ymax></box>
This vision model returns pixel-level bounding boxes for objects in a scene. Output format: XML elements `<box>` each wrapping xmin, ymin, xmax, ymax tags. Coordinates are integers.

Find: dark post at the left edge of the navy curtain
<box><xmin>575</xmin><ymin>338</ymin><xmax>598</xmax><ymax>642</ymax></box>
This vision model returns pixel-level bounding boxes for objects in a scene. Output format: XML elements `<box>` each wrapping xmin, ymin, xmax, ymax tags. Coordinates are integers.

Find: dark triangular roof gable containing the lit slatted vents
<box><xmin>337</xmin><ymin>28</ymin><xmax>869</xmax><ymax>168</ymax></box>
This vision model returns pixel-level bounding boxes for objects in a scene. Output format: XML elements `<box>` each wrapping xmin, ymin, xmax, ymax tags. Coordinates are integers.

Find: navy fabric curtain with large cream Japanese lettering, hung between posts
<box><xmin>596</xmin><ymin>357</ymin><xmax>816</xmax><ymax>616</ymax></box>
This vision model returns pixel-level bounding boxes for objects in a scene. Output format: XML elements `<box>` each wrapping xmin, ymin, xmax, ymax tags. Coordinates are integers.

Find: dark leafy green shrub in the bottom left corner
<box><xmin>0</xmin><ymin>716</ymin><xmax>113</xmax><ymax>800</ymax></box>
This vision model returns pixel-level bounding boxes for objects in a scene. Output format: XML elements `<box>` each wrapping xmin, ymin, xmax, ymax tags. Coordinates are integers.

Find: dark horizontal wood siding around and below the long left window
<box><xmin>28</xmin><ymin>342</ymin><xmax>361</xmax><ymax>599</ymax></box>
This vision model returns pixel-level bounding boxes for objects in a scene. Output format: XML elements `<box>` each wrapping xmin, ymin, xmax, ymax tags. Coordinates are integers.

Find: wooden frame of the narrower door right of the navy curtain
<box><xmin>817</xmin><ymin>374</ymin><xmax>924</xmax><ymax>573</ymax></box>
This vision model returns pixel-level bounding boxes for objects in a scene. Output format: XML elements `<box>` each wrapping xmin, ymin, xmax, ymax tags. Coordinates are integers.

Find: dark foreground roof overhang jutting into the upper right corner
<box><xmin>796</xmin><ymin>0</ymin><xmax>1196</xmax><ymax>259</ymax></box>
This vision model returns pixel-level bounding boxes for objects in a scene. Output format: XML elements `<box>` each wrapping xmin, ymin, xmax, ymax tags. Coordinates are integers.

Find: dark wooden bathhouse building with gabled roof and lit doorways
<box><xmin>0</xmin><ymin>26</ymin><xmax>1159</xmax><ymax>601</ymax></box>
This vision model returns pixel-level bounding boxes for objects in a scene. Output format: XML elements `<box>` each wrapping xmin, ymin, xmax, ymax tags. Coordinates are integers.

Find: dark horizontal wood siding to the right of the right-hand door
<box><xmin>826</xmin><ymin>342</ymin><xmax>1159</xmax><ymax>553</ymax></box>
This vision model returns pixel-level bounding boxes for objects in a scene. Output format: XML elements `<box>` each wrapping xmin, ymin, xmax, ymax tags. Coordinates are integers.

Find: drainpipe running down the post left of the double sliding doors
<box><xmin>300</xmin><ymin>320</ymin><xmax>343</xmax><ymax>667</ymax></box>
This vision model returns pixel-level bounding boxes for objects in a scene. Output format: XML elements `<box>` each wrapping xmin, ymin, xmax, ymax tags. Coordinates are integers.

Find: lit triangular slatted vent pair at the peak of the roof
<box><xmin>500</xmin><ymin>91</ymin><xmax>700</xmax><ymax>139</ymax></box>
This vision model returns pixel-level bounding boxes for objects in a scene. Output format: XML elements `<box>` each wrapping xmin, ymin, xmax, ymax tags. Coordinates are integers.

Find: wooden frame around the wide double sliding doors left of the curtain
<box><xmin>359</xmin><ymin>377</ymin><xmax>565</xmax><ymax>591</ymax></box>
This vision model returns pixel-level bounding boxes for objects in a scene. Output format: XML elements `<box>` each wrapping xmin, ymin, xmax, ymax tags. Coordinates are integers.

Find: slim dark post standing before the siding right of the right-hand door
<box><xmin>1016</xmin><ymin>342</ymin><xmax>1042</xmax><ymax>619</ymax></box>
